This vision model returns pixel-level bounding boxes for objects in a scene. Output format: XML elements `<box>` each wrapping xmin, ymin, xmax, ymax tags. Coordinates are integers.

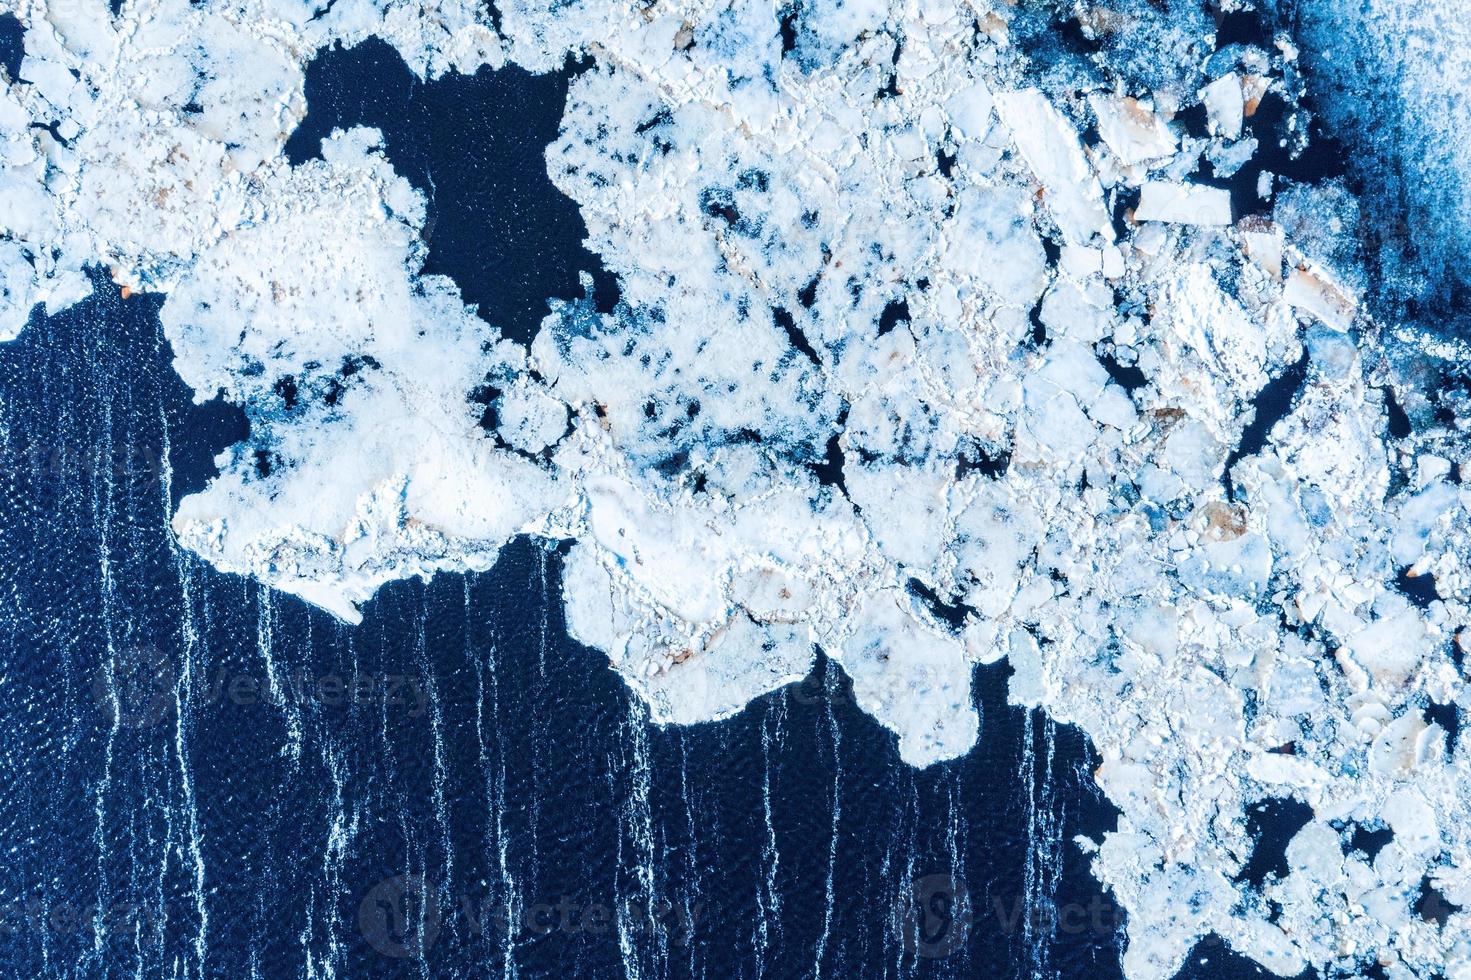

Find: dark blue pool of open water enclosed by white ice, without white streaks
<box><xmin>285</xmin><ymin>38</ymin><xmax>618</xmax><ymax>343</ymax></box>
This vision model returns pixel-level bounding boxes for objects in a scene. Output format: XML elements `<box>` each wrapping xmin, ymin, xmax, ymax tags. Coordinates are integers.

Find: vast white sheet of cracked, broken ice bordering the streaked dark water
<box><xmin>0</xmin><ymin>0</ymin><xmax>1471</xmax><ymax>979</ymax></box>
